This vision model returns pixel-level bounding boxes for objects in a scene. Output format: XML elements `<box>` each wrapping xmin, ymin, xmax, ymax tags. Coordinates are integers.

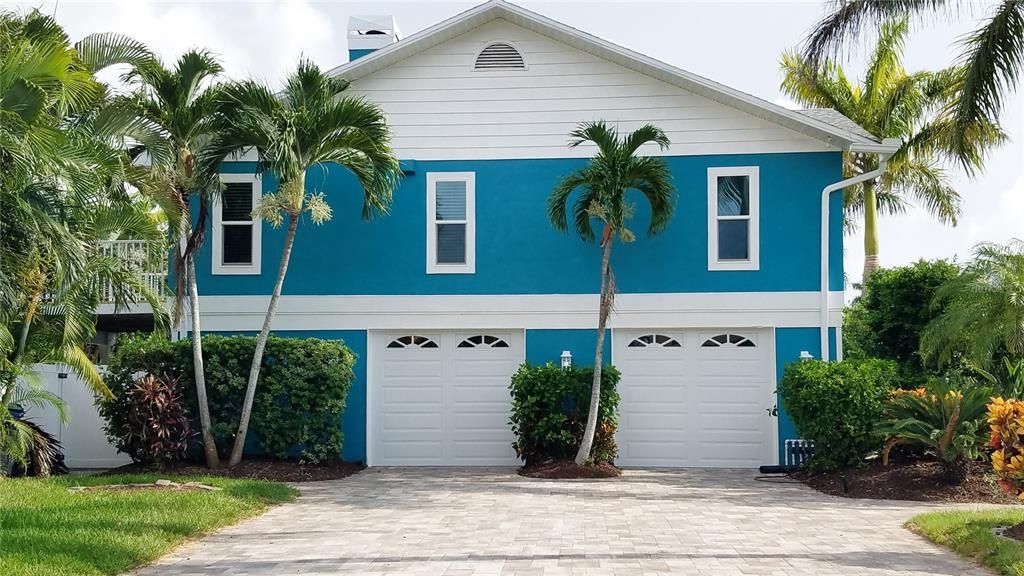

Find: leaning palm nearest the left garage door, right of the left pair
<box><xmin>203</xmin><ymin>59</ymin><xmax>401</xmax><ymax>465</ymax></box>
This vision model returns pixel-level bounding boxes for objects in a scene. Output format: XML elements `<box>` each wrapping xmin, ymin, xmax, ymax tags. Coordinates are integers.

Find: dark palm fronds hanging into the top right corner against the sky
<box><xmin>804</xmin><ymin>0</ymin><xmax>1024</xmax><ymax>158</ymax></box>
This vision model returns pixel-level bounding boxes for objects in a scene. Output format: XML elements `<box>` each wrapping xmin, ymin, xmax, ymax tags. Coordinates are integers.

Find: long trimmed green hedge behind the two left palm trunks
<box><xmin>97</xmin><ymin>334</ymin><xmax>356</xmax><ymax>461</ymax></box>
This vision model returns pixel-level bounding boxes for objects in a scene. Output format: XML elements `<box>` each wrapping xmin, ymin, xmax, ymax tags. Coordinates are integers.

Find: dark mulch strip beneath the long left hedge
<box><xmin>103</xmin><ymin>458</ymin><xmax>366</xmax><ymax>482</ymax></box>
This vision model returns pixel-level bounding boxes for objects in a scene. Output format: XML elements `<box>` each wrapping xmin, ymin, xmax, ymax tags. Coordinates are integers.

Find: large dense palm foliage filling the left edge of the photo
<box><xmin>0</xmin><ymin>11</ymin><xmax>166</xmax><ymax>471</ymax></box>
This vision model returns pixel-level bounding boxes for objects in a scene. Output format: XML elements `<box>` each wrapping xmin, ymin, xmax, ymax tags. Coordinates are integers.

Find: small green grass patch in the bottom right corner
<box><xmin>906</xmin><ymin>508</ymin><xmax>1024</xmax><ymax>576</ymax></box>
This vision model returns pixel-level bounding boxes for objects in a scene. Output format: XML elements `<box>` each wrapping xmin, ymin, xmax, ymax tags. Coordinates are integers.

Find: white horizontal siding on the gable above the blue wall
<box><xmin>351</xmin><ymin>19</ymin><xmax>835</xmax><ymax>160</ymax></box>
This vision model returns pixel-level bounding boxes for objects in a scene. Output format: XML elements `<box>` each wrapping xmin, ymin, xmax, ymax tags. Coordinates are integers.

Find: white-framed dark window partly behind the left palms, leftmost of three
<box><xmin>213</xmin><ymin>174</ymin><xmax>262</xmax><ymax>275</ymax></box>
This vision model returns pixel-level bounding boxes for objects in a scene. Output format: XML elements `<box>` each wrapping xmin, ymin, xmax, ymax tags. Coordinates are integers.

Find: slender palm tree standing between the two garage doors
<box><xmin>548</xmin><ymin>121</ymin><xmax>675</xmax><ymax>465</ymax></box>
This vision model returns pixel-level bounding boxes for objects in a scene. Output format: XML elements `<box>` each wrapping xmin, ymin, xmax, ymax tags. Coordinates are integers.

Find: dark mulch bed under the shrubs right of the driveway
<box><xmin>793</xmin><ymin>460</ymin><xmax>1020</xmax><ymax>504</ymax></box>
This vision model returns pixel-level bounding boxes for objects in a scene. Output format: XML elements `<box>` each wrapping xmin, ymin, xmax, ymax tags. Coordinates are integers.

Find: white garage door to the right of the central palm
<box><xmin>613</xmin><ymin>329</ymin><xmax>775</xmax><ymax>468</ymax></box>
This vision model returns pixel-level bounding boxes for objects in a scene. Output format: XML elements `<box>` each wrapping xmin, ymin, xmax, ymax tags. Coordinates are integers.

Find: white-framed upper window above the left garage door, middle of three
<box><xmin>427</xmin><ymin>172</ymin><xmax>476</xmax><ymax>274</ymax></box>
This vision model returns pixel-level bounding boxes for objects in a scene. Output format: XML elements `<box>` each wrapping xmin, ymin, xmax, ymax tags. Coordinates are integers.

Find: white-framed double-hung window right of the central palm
<box><xmin>708</xmin><ymin>166</ymin><xmax>761</xmax><ymax>271</ymax></box>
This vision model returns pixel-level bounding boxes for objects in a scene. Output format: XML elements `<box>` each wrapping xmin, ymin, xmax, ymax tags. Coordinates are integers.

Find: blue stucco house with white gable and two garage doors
<box><xmin>190</xmin><ymin>0</ymin><xmax>896</xmax><ymax>467</ymax></box>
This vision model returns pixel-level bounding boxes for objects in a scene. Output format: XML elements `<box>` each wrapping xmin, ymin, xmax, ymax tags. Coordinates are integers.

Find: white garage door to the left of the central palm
<box><xmin>368</xmin><ymin>330</ymin><xmax>523</xmax><ymax>466</ymax></box>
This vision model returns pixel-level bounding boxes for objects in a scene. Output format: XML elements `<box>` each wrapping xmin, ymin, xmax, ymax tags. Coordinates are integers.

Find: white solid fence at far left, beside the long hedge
<box><xmin>25</xmin><ymin>364</ymin><xmax>131</xmax><ymax>468</ymax></box>
